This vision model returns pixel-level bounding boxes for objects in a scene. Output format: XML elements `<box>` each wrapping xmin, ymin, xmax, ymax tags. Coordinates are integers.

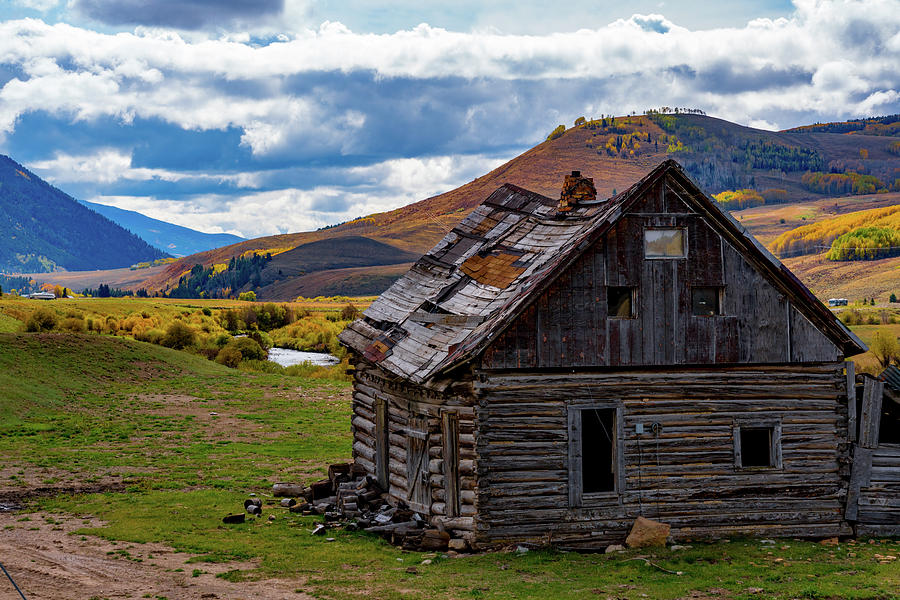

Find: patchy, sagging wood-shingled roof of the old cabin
<box><xmin>340</xmin><ymin>160</ymin><xmax>866</xmax><ymax>387</ymax></box>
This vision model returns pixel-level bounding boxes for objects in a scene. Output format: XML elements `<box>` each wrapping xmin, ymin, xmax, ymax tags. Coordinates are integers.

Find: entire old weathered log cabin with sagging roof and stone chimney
<box><xmin>341</xmin><ymin>161</ymin><xmax>864</xmax><ymax>548</ymax></box>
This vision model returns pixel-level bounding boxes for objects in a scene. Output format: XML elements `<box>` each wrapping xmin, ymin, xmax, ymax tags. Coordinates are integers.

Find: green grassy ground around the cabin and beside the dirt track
<box><xmin>0</xmin><ymin>333</ymin><xmax>900</xmax><ymax>599</ymax></box>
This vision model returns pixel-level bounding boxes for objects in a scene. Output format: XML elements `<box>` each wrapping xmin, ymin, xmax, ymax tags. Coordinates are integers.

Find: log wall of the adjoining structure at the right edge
<box><xmin>857</xmin><ymin>444</ymin><xmax>900</xmax><ymax>535</ymax></box>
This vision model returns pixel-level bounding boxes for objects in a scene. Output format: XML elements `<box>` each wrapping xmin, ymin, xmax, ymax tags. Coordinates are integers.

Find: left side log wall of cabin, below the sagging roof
<box><xmin>351</xmin><ymin>361</ymin><xmax>476</xmax><ymax>530</ymax></box>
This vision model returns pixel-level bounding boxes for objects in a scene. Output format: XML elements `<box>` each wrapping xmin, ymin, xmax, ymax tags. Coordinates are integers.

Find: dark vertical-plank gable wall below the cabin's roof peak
<box><xmin>483</xmin><ymin>182</ymin><xmax>841</xmax><ymax>369</ymax></box>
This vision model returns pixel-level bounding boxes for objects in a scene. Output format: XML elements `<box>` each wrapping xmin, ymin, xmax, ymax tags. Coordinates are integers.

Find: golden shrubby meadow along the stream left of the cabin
<box><xmin>0</xmin><ymin>294</ymin><xmax>373</xmax><ymax>379</ymax></box>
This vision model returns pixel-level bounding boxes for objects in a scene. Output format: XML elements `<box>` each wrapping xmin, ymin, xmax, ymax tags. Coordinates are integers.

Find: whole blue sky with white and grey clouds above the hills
<box><xmin>0</xmin><ymin>0</ymin><xmax>900</xmax><ymax>237</ymax></box>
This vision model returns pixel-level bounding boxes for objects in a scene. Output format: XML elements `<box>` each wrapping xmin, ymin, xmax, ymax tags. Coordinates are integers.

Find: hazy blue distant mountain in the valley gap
<box><xmin>79</xmin><ymin>200</ymin><xmax>244</xmax><ymax>257</ymax></box>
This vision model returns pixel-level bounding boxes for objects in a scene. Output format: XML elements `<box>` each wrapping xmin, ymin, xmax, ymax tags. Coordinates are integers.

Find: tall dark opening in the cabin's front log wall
<box><xmin>581</xmin><ymin>408</ymin><xmax>616</xmax><ymax>494</ymax></box>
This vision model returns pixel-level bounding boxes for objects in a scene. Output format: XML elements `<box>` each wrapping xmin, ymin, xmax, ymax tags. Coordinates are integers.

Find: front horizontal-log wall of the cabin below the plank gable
<box><xmin>476</xmin><ymin>364</ymin><xmax>850</xmax><ymax>547</ymax></box>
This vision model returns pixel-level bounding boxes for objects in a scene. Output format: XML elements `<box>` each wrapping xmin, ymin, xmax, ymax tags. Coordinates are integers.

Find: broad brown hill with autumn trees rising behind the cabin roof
<box><xmin>118</xmin><ymin>113</ymin><xmax>900</xmax><ymax>298</ymax></box>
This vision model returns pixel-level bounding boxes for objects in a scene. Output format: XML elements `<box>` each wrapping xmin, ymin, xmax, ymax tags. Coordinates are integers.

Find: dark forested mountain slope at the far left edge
<box><xmin>0</xmin><ymin>155</ymin><xmax>166</xmax><ymax>273</ymax></box>
